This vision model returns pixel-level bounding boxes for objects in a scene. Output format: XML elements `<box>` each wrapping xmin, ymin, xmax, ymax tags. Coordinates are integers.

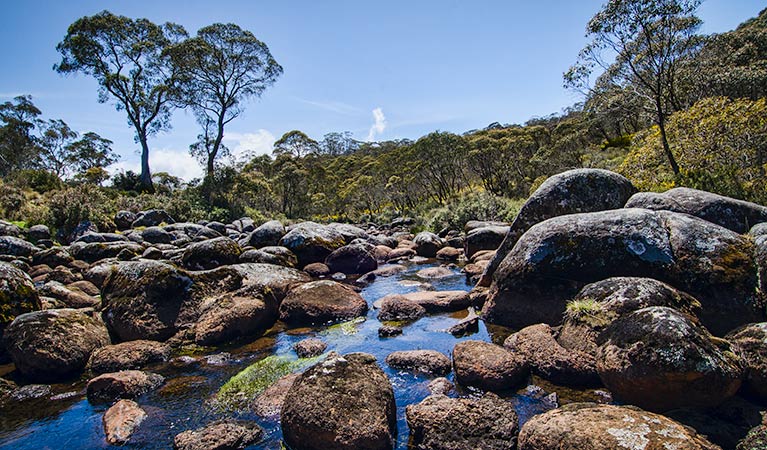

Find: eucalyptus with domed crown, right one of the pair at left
<box><xmin>165</xmin><ymin>23</ymin><xmax>282</xmax><ymax>176</ymax></box>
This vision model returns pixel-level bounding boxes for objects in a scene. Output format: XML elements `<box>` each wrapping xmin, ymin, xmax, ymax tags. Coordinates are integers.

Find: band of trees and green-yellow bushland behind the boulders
<box><xmin>0</xmin><ymin>0</ymin><xmax>767</xmax><ymax>239</ymax></box>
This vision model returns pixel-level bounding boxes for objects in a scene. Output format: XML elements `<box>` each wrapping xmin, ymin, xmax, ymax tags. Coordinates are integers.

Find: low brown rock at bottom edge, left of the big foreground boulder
<box><xmin>173</xmin><ymin>421</ymin><xmax>264</xmax><ymax>450</ymax></box>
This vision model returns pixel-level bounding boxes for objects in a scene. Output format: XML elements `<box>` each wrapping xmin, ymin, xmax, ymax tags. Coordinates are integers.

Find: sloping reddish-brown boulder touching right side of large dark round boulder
<box><xmin>194</xmin><ymin>294</ymin><xmax>277</xmax><ymax>345</ymax></box>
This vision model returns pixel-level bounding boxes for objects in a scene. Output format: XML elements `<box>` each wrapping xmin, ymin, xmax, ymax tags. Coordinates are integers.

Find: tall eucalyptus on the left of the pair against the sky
<box><xmin>54</xmin><ymin>11</ymin><xmax>187</xmax><ymax>191</ymax></box>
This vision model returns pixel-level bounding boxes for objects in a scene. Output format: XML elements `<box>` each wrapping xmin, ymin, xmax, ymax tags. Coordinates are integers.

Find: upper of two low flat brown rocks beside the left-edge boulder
<box><xmin>88</xmin><ymin>340</ymin><xmax>170</xmax><ymax>373</ymax></box>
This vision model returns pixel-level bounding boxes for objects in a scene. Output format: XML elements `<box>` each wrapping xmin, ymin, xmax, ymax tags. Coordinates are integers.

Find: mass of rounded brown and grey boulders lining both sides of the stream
<box><xmin>0</xmin><ymin>169</ymin><xmax>767</xmax><ymax>450</ymax></box>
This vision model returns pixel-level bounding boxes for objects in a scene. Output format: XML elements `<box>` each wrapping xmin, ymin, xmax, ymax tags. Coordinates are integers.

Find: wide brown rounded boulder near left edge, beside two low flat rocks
<box><xmin>3</xmin><ymin>309</ymin><xmax>110</xmax><ymax>381</ymax></box>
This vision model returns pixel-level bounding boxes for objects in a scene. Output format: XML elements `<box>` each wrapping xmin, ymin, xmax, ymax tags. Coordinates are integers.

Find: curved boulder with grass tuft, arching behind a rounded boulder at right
<box><xmin>557</xmin><ymin>277</ymin><xmax>700</xmax><ymax>356</ymax></box>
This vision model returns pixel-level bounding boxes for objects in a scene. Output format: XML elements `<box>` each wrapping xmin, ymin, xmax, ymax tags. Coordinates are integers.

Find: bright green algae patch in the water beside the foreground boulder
<box><xmin>216</xmin><ymin>355</ymin><xmax>323</xmax><ymax>410</ymax></box>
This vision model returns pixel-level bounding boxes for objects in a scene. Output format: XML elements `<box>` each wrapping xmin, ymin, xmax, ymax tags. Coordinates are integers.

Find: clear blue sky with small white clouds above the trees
<box><xmin>0</xmin><ymin>0</ymin><xmax>765</xmax><ymax>179</ymax></box>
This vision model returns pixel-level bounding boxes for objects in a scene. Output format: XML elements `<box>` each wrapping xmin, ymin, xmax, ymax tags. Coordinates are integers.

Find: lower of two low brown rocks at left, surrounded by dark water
<box><xmin>86</xmin><ymin>370</ymin><xmax>165</xmax><ymax>403</ymax></box>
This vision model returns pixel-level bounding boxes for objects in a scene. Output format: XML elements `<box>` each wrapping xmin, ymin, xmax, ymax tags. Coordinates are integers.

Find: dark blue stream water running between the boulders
<box><xmin>0</xmin><ymin>262</ymin><xmax>608</xmax><ymax>449</ymax></box>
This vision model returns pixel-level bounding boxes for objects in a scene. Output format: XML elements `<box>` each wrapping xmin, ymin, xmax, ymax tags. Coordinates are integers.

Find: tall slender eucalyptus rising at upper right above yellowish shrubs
<box><xmin>564</xmin><ymin>0</ymin><xmax>701</xmax><ymax>175</ymax></box>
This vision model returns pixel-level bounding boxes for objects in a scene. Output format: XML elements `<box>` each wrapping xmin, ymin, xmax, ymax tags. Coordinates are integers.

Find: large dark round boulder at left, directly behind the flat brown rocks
<box><xmin>101</xmin><ymin>260</ymin><xmax>198</xmax><ymax>341</ymax></box>
